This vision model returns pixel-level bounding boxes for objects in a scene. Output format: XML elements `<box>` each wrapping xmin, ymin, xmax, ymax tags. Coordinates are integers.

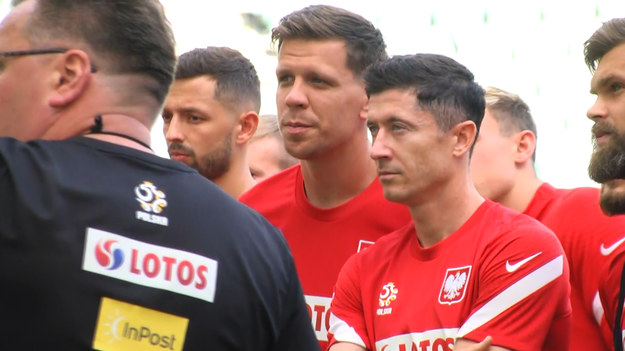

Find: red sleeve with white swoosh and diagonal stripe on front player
<box><xmin>458</xmin><ymin>220</ymin><xmax>571</xmax><ymax>350</ymax></box>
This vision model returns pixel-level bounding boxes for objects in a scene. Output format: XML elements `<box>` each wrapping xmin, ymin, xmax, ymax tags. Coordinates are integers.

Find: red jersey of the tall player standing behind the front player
<box><xmin>239</xmin><ymin>164</ymin><xmax>411</xmax><ymax>349</ymax></box>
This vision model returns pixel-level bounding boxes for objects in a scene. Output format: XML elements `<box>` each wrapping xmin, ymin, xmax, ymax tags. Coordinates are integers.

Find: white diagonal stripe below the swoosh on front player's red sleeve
<box><xmin>457</xmin><ymin>255</ymin><xmax>564</xmax><ymax>338</ymax></box>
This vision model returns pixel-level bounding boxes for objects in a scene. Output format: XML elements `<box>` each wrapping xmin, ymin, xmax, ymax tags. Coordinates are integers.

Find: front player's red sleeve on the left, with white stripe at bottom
<box><xmin>328</xmin><ymin>254</ymin><xmax>372</xmax><ymax>350</ymax></box>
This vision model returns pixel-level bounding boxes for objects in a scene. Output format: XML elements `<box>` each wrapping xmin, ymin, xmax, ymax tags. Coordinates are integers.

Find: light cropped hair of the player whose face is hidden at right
<box><xmin>484</xmin><ymin>87</ymin><xmax>538</xmax><ymax>161</ymax></box>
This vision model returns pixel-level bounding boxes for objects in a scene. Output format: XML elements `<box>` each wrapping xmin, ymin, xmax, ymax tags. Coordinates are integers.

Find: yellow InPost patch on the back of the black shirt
<box><xmin>93</xmin><ymin>297</ymin><xmax>189</xmax><ymax>351</ymax></box>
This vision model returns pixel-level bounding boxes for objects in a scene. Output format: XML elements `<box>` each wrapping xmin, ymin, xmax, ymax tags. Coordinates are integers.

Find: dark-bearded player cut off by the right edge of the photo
<box><xmin>584</xmin><ymin>18</ymin><xmax>625</xmax><ymax>350</ymax></box>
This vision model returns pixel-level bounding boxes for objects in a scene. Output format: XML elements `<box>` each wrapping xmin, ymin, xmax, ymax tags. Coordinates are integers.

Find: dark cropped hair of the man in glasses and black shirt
<box><xmin>20</xmin><ymin>0</ymin><xmax>176</xmax><ymax>103</ymax></box>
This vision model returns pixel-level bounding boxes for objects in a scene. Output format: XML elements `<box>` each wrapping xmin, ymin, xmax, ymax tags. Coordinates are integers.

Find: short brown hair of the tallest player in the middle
<box><xmin>271</xmin><ymin>5</ymin><xmax>387</xmax><ymax>77</ymax></box>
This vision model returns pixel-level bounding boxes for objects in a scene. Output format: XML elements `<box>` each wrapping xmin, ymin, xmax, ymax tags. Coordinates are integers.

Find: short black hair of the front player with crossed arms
<box><xmin>365</xmin><ymin>54</ymin><xmax>485</xmax><ymax>132</ymax></box>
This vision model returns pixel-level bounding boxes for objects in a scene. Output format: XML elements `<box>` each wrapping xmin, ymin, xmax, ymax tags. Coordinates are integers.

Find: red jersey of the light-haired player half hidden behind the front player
<box><xmin>524</xmin><ymin>183</ymin><xmax>625</xmax><ymax>351</ymax></box>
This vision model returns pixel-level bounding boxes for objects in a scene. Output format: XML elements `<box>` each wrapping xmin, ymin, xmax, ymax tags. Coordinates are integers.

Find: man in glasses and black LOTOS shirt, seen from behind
<box><xmin>0</xmin><ymin>0</ymin><xmax>318</xmax><ymax>350</ymax></box>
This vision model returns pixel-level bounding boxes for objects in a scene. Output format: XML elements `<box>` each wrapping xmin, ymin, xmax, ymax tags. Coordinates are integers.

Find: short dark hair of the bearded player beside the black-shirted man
<box><xmin>176</xmin><ymin>46</ymin><xmax>260</xmax><ymax>113</ymax></box>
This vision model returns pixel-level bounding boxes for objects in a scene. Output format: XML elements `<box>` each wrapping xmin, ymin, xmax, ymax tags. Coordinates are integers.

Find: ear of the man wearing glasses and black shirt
<box><xmin>48</xmin><ymin>50</ymin><xmax>92</xmax><ymax>107</ymax></box>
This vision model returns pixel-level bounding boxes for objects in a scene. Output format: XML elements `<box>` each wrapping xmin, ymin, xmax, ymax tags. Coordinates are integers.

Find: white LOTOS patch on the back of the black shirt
<box><xmin>82</xmin><ymin>228</ymin><xmax>218</xmax><ymax>302</ymax></box>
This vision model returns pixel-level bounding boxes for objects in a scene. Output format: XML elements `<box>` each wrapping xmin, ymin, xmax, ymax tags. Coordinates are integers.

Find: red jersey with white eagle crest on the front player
<box><xmin>330</xmin><ymin>200</ymin><xmax>571</xmax><ymax>351</ymax></box>
